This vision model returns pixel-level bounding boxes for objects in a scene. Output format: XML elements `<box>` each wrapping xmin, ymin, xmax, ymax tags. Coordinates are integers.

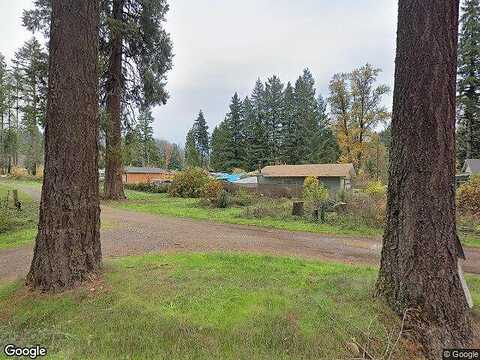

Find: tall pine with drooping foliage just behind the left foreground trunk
<box><xmin>23</xmin><ymin>0</ymin><xmax>173</xmax><ymax>199</ymax></box>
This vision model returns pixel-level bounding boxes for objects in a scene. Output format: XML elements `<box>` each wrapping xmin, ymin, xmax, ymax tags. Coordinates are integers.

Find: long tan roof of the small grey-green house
<box><xmin>261</xmin><ymin>164</ymin><xmax>355</xmax><ymax>178</ymax></box>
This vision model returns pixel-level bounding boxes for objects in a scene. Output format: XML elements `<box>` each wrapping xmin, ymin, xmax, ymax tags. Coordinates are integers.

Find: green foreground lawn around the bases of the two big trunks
<box><xmin>0</xmin><ymin>254</ymin><xmax>480</xmax><ymax>359</ymax></box>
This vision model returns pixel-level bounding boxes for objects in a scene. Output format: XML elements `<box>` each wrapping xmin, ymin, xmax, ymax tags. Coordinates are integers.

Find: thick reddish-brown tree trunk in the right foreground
<box><xmin>377</xmin><ymin>0</ymin><xmax>472</xmax><ymax>359</ymax></box>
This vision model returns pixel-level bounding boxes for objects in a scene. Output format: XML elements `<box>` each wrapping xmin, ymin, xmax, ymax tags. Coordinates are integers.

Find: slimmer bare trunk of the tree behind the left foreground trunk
<box><xmin>104</xmin><ymin>0</ymin><xmax>125</xmax><ymax>200</ymax></box>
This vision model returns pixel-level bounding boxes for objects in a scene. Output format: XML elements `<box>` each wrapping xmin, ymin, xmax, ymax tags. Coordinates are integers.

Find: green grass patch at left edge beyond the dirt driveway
<box><xmin>0</xmin><ymin>182</ymin><xmax>38</xmax><ymax>249</ymax></box>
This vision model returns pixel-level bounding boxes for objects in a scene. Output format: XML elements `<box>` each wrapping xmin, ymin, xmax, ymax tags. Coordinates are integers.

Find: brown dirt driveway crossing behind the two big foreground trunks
<box><xmin>0</xmin><ymin>184</ymin><xmax>480</xmax><ymax>282</ymax></box>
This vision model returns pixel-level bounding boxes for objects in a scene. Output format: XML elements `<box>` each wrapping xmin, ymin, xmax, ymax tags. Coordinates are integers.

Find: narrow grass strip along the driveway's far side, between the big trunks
<box><xmin>106</xmin><ymin>191</ymin><xmax>382</xmax><ymax>236</ymax></box>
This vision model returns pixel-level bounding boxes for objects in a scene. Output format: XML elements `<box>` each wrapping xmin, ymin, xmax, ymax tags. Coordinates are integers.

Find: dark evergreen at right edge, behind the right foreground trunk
<box><xmin>457</xmin><ymin>0</ymin><xmax>480</xmax><ymax>165</ymax></box>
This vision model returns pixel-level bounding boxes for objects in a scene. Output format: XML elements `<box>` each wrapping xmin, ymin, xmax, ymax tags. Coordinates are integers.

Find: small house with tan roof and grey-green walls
<box><xmin>258</xmin><ymin>164</ymin><xmax>355</xmax><ymax>194</ymax></box>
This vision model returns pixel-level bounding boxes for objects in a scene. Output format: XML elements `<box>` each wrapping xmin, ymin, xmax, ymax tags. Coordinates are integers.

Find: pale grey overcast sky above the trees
<box><xmin>0</xmin><ymin>0</ymin><xmax>398</xmax><ymax>143</ymax></box>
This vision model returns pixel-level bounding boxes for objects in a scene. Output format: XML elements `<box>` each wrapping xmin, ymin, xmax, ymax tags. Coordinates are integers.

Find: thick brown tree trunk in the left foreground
<box><xmin>27</xmin><ymin>0</ymin><xmax>102</xmax><ymax>291</ymax></box>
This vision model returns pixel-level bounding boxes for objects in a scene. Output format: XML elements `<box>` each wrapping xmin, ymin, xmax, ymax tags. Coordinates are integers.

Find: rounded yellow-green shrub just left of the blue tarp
<box><xmin>168</xmin><ymin>168</ymin><xmax>210</xmax><ymax>198</ymax></box>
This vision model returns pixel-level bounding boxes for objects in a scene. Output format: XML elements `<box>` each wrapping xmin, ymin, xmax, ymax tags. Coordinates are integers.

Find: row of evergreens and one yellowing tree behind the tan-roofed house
<box><xmin>185</xmin><ymin>64</ymin><xmax>390</xmax><ymax>177</ymax></box>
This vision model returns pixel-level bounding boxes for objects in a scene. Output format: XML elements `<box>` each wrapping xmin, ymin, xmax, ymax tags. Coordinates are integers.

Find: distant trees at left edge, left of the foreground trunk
<box><xmin>0</xmin><ymin>38</ymin><xmax>48</xmax><ymax>175</ymax></box>
